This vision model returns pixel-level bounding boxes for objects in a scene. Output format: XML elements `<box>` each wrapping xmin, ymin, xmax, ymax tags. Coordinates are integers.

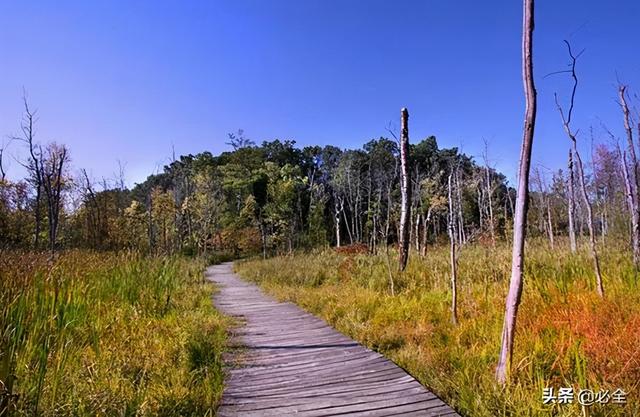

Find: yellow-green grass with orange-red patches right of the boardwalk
<box><xmin>236</xmin><ymin>242</ymin><xmax>640</xmax><ymax>417</ymax></box>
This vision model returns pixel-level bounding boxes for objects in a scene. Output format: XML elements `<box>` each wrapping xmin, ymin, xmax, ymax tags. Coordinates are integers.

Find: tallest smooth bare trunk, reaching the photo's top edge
<box><xmin>496</xmin><ymin>0</ymin><xmax>537</xmax><ymax>385</ymax></box>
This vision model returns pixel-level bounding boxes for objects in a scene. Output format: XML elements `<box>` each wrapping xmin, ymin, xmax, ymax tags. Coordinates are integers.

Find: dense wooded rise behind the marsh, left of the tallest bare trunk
<box><xmin>0</xmin><ymin>123</ymin><xmax>513</xmax><ymax>254</ymax></box>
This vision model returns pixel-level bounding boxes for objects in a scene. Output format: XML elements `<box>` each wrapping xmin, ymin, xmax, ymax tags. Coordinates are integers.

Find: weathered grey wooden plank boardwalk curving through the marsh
<box><xmin>207</xmin><ymin>263</ymin><xmax>458</xmax><ymax>417</ymax></box>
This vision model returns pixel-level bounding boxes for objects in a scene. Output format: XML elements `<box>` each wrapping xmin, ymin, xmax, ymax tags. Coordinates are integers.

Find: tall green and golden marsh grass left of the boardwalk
<box><xmin>0</xmin><ymin>251</ymin><xmax>226</xmax><ymax>416</ymax></box>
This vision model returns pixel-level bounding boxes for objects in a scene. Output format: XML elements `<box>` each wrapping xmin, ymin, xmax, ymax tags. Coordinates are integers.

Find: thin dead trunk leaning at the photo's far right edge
<box><xmin>618</xmin><ymin>85</ymin><xmax>640</xmax><ymax>267</ymax></box>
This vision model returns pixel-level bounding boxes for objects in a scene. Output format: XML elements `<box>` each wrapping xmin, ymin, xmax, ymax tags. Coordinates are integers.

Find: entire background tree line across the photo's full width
<box><xmin>0</xmin><ymin>97</ymin><xmax>638</xmax><ymax>261</ymax></box>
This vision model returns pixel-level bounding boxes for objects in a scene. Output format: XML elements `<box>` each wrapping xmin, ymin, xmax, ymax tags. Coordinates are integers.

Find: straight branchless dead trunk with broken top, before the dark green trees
<box><xmin>398</xmin><ymin>108</ymin><xmax>411</xmax><ymax>271</ymax></box>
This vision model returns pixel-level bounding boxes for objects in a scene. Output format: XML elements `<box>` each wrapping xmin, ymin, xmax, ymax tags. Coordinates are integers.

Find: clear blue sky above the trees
<box><xmin>0</xmin><ymin>0</ymin><xmax>640</xmax><ymax>183</ymax></box>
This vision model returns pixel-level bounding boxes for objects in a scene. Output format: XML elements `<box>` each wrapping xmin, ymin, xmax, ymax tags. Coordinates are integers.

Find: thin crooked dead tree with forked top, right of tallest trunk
<box><xmin>555</xmin><ymin>40</ymin><xmax>604</xmax><ymax>297</ymax></box>
